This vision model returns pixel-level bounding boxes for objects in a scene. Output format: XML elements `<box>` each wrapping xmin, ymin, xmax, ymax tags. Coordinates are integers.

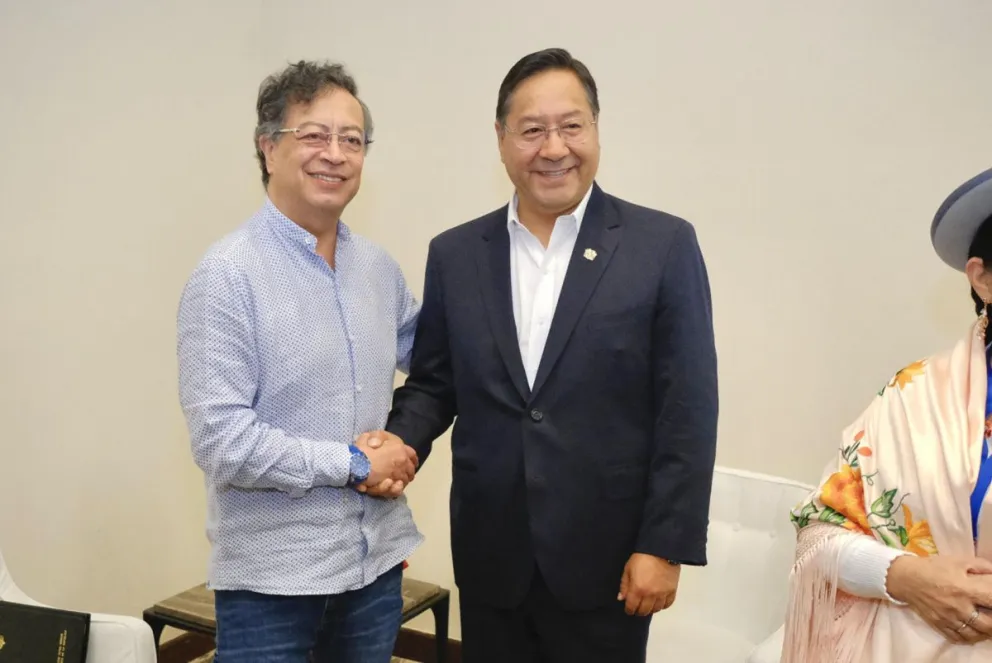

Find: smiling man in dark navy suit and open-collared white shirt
<box><xmin>370</xmin><ymin>49</ymin><xmax>717</xmax><ymax>663</ymax></box>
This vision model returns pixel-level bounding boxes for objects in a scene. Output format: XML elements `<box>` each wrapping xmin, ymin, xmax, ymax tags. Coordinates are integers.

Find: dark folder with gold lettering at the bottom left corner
<box><xmin>0</xmin><ymin>601</ymin><xmax>90</xmax><ymax>663</ymax></box>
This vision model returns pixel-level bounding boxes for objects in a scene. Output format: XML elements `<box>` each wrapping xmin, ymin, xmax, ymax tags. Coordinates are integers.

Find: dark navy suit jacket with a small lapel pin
<box><xmin>387</xmin><ymin>185</ymin><xmax>718</xmax><ymax>609</ymax></box>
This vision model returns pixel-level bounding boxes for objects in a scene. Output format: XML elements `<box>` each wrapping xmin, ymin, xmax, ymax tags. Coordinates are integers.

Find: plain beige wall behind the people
<box><xmin>0</xmin><ymin>0</ymin><xmax>992</xmax><ymax>635</ymax></box>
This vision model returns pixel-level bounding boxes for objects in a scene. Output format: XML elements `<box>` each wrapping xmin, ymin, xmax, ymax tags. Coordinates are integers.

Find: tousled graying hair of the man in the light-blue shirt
<box><xmin>255</xmin><ymin>60</ymin><xmax>375</xmax><ymax>186</ymax></box>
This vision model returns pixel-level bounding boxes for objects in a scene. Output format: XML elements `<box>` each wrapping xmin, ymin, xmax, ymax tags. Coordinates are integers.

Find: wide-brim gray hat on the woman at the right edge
<box><xmin>930</xmin><ymin>169</ymin><xmax>992</xmax><ymax>272</ymax></box>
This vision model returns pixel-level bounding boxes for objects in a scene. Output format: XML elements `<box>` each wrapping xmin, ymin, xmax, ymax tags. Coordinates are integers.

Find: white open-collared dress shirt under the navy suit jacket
<box><xmin>506</xmin><ymin>187</ymin><xmax>592</xmax><ymax>387</ymax></box>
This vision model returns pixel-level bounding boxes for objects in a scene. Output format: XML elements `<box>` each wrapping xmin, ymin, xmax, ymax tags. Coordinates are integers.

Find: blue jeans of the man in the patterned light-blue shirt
<box><xmin>214</xmin><ymin>565</ymin><xmax>403</xmax><ymax>663</ymax></box>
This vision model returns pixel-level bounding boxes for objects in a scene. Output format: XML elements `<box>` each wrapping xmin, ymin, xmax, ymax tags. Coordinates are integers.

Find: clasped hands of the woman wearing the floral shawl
<box><xmin>886</xmin><ymin>555</ymin><xmax>992</xmax><ymax>644</ymax></box>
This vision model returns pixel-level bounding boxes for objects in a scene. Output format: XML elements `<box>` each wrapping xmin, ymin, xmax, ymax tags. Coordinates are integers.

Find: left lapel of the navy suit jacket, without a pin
<box><xmin>478</xmin><ymin>207</ymin><xmax>530</xmax><ymax>401</ymax></box>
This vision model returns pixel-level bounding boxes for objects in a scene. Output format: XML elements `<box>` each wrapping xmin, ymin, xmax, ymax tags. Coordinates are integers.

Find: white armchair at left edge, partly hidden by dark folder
<box><xmin>0</xmin><ymin>552</ymin><xmax>156</xmax><ymax>663</ymax></box>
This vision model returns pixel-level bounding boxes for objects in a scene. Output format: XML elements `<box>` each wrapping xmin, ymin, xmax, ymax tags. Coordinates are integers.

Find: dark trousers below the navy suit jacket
<box><xmin>459</xmin><ymin>571</ymin><xmax>651</xmax><ymax>663</ymax></box>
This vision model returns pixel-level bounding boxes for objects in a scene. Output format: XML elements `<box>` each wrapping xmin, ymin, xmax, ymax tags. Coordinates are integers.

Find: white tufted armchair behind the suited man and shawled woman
<box><xmin>647</xmin><ymin>467</ymin><xmax>813</xmax><ymax>663</ymax></box>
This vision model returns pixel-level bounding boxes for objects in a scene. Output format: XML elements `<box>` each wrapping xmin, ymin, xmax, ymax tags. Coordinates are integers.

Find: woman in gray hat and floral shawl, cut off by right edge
<box><xmin>782</xmin><ymin>170</ymin><xmax>992</xmax><ymax>663</ymax></box>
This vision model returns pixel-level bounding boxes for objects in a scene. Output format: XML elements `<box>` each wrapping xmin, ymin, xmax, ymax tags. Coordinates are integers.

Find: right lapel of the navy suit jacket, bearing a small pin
<box><xmin>531</xmin><ymin>184</ymin><xmax>620</xmax><ymax>398</ymax></box>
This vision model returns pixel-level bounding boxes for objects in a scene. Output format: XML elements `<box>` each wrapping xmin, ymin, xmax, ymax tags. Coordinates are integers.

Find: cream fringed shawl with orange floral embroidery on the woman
<box><xmin>782</xmin><ymin>325</ymin><xmax>992</xmax><ymax>663</ymax></box>
